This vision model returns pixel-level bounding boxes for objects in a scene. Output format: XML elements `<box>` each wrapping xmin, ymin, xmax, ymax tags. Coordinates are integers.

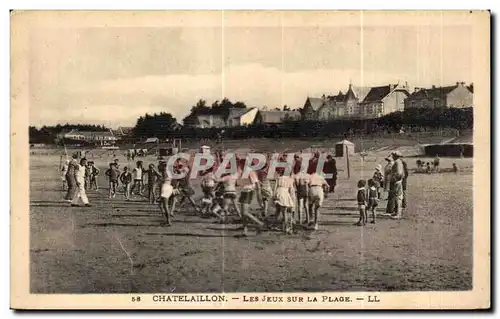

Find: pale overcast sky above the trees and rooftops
<box><xmin>29</xmin><ymin>12</ymin><xmax>473</xmax><ymax>127</ymax></box>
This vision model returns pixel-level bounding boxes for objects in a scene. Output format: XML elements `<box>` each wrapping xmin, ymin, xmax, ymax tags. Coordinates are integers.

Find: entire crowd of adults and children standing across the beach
<box><xmin>61</xmin><ymin>152</ymin><xmax>414</xmax><ymax>235</ymax></box>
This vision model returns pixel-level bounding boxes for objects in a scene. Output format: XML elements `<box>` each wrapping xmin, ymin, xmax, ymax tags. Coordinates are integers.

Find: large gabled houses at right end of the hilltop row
<box><xmin>302</xmin><ymin>82</ymin><xmax>474</xmax><ymax>120</ymax></box>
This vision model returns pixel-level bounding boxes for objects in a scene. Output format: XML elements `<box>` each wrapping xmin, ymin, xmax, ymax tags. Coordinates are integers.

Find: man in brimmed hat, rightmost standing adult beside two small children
<box><xmin>387</xmin><ymin>151</ymin><xmax>404</xmax><ymax>219</ymax></box>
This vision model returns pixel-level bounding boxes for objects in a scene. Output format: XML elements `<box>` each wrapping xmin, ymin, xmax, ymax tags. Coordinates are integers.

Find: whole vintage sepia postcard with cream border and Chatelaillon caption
<box><xmin>10</xmin><ymin>11</ymin><xmax>491</xmax><ymax>310</ymax></box>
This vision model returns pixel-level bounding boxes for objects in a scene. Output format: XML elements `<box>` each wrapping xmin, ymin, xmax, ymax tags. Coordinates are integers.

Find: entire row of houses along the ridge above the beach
<box><xmin>191</xmin><ymin>82</ymin><xmax>474</xmax><ymax>128</ymax></box>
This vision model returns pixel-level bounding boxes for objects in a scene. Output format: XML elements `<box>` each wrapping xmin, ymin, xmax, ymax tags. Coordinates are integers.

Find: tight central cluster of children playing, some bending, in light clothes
<box><xmin>153</xmin><ymin>160</ymin><xmax>329</xmax><ymax>236</ymax></box>
